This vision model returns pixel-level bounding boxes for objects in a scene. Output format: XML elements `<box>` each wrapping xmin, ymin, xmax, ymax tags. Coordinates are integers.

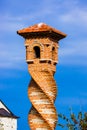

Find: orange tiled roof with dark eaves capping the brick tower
<box><xmin>17</xmin><ymin>23</ymin><xmax>66</xmax><ymax>41</ymax></box>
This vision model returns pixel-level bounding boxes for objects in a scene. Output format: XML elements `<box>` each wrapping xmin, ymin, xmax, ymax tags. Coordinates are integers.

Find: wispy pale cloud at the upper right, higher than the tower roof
<box><xmin>60</xmin><ymin>8</ymin><xmax>87</xmax><ymax>27</ymax></box>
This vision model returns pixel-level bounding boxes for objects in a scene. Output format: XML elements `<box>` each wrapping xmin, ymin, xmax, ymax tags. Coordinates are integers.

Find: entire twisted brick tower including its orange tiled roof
<box><xmin>17</xmin><ymin>23</ymin><xmax>66</xmax><ymax>130</ymax></box>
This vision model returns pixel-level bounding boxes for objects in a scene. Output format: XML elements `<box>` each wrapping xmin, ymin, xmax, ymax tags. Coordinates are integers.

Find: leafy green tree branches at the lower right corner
<box><xmin>58</xmin><ymin>109</ymin><xmax>87</xmax><ymax>130</ymax></box>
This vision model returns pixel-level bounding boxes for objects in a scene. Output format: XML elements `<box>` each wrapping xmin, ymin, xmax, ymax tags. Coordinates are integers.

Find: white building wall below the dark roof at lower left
<box><xmin>0</xmin><ymin>117</ymin><xmax>17</xmax><ymax>130</ymax></box>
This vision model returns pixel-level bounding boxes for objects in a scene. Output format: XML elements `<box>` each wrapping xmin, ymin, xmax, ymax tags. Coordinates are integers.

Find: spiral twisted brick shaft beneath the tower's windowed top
<box><xmin>28</xmin><ymin>69</ymin><xmax>57</xmax><ymax>130</ymax></box>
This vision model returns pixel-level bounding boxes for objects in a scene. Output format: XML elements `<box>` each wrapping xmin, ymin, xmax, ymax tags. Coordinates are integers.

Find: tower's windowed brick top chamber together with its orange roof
<box><xmin>17</xmin><ymin>23</ymin><xmax>66</xmax><ymax>73</ymax></box>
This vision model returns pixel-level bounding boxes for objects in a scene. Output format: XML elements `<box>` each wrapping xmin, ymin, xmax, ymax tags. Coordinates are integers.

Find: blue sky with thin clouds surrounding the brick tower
<box><xmin>0</xmin><ymin>0</ymin><xmax>87</xmax><ymax>130</ymax></box>
